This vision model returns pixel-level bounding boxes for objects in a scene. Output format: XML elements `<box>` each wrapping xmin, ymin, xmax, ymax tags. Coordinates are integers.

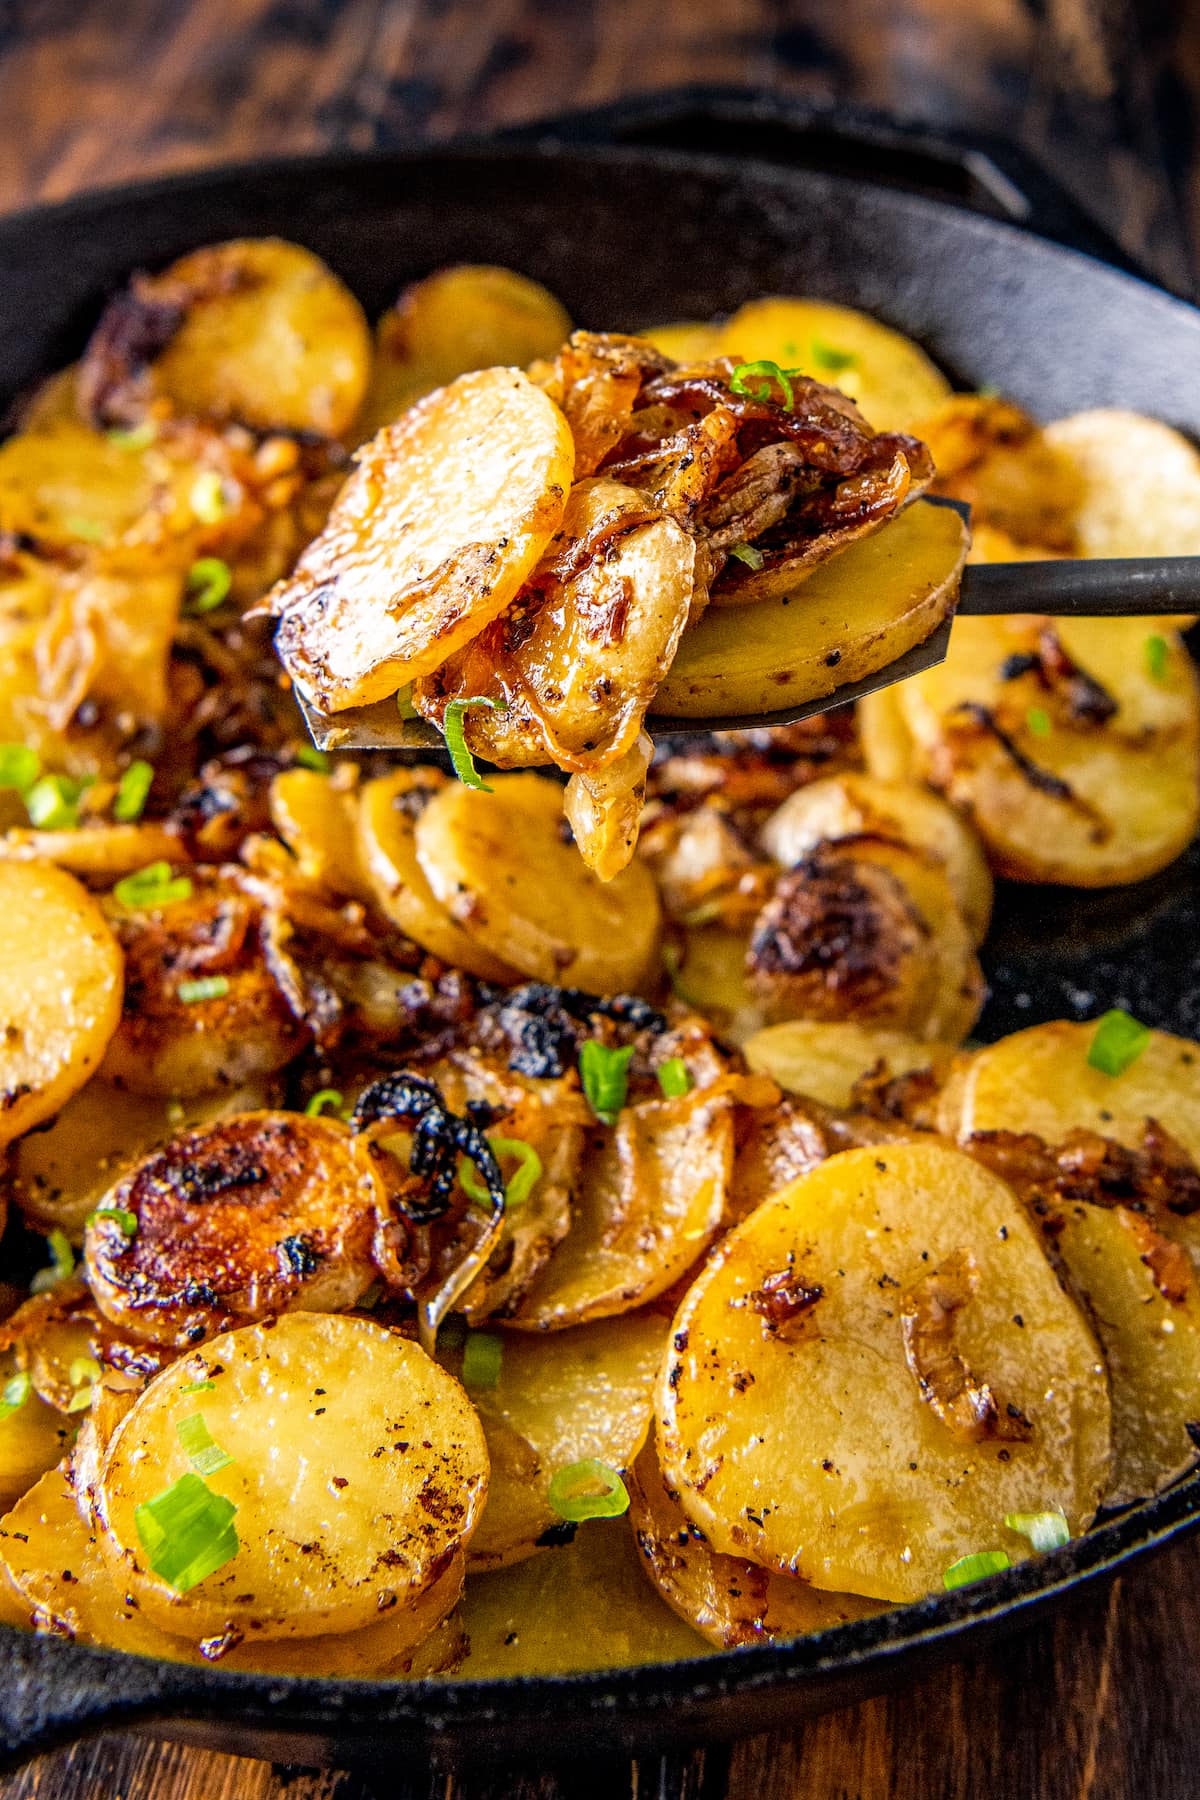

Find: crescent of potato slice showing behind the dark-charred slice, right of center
<box><xmin>763</xmin><ymin>772</ymin><xmax>991</xmax><ymax>943</ymax></box>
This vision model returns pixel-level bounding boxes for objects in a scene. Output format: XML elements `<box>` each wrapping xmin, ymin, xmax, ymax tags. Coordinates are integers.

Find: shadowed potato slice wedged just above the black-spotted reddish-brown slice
<box><xmin>11</xmin><ymin>1075</ymin><xmax>264</xmax><ymax>1244</ymax></box>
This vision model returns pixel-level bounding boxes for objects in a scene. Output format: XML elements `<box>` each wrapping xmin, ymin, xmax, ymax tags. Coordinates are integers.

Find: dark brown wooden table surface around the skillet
<box><xmin>0</xmin><ymin>0</ymin><xmax>1200</xmax><ymax>1800</ymax></box>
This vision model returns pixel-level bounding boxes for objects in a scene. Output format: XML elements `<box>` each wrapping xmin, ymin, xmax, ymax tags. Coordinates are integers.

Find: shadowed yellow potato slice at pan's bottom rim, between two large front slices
<box><xmin>459</xmin><ymin>1519</ymin><xmax>707</xmax><ymax>1681</ymax></box>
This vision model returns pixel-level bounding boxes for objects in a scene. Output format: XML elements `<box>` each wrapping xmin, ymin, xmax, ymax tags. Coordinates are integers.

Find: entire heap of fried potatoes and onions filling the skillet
<box><xmin>0</xmin><ymin>241</ymin><xmax>1200</xmax><ymax>1679</ymax></box>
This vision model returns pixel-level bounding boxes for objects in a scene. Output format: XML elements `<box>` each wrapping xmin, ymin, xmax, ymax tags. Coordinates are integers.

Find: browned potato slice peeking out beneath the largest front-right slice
<box><xmin>626</xmin><ymin>1444</ymin><xmax>880</xmax><ymax>1651</ymax></box>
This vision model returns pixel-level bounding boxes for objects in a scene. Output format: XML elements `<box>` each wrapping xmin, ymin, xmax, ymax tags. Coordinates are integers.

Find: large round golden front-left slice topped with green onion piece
<box><xmin>95</xmin><ymin>1312</ymin><xmax>488</xmax><ymax>1638</ymax></box>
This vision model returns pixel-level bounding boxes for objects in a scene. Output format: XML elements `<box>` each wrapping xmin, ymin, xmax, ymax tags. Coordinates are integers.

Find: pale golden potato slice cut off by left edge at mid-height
<box><xmin>0</xmin><ymin>859</ymin><xmax>122</xmax><ymax>1143</ymax></box>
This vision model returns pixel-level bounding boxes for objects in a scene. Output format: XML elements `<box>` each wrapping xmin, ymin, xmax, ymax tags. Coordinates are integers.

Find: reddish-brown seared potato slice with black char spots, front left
<box><xmin>85</xmin><ymin>1112</ymin><xmax>385</xmax><ymax>1350</ymax></box>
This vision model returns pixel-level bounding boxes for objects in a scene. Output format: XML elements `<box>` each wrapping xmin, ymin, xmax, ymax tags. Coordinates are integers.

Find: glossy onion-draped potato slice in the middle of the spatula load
<box><xmin>412</xmin><ymin>475</ymin><xmax>696</xmax><ymax>772</ymax></box>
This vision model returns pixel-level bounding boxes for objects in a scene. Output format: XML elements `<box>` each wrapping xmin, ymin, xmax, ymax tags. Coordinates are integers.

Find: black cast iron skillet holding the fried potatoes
<box><xmin>0</xmin><ymin>97</ymin><xmax>1200</xmax><ymax>1777</ymax></box>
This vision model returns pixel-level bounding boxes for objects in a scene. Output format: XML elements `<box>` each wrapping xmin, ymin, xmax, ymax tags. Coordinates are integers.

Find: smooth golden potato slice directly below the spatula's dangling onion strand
<box><xmin>416</xmin><ymin>774</ymin><xmax>658</xmax><ymax>994</ymax></box>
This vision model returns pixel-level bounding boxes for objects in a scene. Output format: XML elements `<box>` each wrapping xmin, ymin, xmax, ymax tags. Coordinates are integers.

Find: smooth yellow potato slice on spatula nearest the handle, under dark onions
<box><xmin>653</xmin><ymin>504</ymin><xmax>966</xmax><ymax>718</ymax></box>
